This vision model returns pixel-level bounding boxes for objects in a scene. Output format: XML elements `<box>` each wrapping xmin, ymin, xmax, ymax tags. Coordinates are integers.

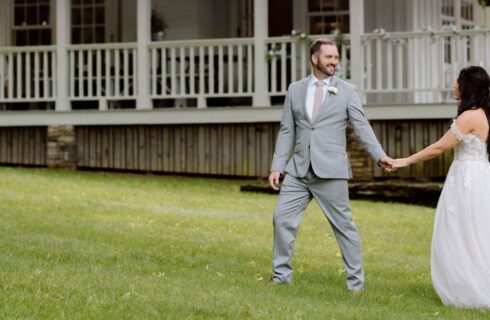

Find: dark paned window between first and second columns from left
<box><xmin>71</xmin><ymin>0</ymin><xmax>106</xmax><ymax>44</ymax></box>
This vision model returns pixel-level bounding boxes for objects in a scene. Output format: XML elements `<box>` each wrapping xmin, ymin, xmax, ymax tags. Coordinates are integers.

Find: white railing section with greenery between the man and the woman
<box><xmin>361</xmin><ymin>30</ymin><xmax>490</xmax><ymax>103</ymax></box>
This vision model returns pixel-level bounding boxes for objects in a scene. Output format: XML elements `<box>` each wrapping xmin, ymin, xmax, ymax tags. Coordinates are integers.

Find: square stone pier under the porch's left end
<box><xmin>47</xmin><ymin>125</ymin><xmax>77</xmax><ymax>170</ymax></box>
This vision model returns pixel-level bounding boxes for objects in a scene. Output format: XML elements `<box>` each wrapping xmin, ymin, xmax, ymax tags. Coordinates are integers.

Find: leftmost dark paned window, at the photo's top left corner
<box><xmin>12</xmin><ymin>0</ymin><xmax>52</xmax><ymax>46</ymax></box>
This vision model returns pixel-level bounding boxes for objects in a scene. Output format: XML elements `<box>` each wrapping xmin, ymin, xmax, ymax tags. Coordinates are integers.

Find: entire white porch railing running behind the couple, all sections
<box><xmin>0</xmin><ymin>30</ymin><xmax>490</xmax><ymax>110</ymax></box>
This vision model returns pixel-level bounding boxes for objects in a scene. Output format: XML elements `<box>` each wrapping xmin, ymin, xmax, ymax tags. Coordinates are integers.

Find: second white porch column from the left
<box><xmin>136</xmin><ymin>0</ymin><xmax>152</xmax><ymax>109</ymax></box>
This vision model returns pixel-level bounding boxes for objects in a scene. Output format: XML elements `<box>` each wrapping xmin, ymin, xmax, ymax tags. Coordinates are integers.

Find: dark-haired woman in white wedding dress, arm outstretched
<box><xmin>393</xmin><ymin>66</ymin><xmax>490</xmax><ymax>308</ymax></box>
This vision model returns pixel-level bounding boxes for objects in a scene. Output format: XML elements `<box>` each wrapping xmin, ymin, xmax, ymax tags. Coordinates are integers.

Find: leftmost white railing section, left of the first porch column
<box><xmin>0</xmin><ymin>46</ymin><xmax>56</xmax><ymax>102</ymax></box>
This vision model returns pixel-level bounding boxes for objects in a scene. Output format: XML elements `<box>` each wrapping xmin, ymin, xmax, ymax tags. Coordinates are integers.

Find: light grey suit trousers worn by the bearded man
<box><xmin>272</xmin><ymin>167</ymin><xmax>364</xmax><ymax>290</ymax></box>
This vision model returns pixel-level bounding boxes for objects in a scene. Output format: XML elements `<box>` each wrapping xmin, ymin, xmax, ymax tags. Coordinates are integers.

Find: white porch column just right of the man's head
<box><xmin>348</xmin><ymin>0</ymin><xmax>365</xmax><ymax>102</ymax></box>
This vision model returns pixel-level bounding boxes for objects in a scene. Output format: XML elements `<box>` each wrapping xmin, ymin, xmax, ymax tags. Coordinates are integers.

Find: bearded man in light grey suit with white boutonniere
<box><xmin>269</xmin><ymin>39</ymin><xmax>393</xmax><ymax>291</ymax></box>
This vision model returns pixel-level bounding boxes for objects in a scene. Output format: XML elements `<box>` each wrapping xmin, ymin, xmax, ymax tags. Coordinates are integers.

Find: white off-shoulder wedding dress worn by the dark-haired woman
<box><xmin>431</xmin><ymin>121</ymin><xmax>490</xmax><ymax>308</ymax></box>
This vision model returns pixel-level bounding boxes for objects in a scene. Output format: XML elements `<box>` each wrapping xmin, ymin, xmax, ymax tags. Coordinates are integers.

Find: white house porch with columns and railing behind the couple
<box><xmin>0</xmin><ymin>0</ymin><xmax>490</xmax><ymax>180</ymax></box>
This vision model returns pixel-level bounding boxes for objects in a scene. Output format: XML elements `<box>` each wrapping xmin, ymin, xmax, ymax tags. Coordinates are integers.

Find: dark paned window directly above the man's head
<box><xmin>308</xmin><ymin>0</ymin><xmax>349</xmax><ymax>34</ymax></box>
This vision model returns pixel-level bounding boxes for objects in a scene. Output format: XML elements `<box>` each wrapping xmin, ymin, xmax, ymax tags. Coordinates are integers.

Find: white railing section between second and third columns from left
<box><xmin>149</xmin><ymin>39</ymin><xmax>254</xmax><ymax>107</ymax></box>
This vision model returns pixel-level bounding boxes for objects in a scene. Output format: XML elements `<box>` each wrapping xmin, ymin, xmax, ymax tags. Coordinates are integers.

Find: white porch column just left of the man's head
<box><xmin>252</xmin><ymin>0</ymin><xmax>271</xmax><ymax>107</ymax></box>
